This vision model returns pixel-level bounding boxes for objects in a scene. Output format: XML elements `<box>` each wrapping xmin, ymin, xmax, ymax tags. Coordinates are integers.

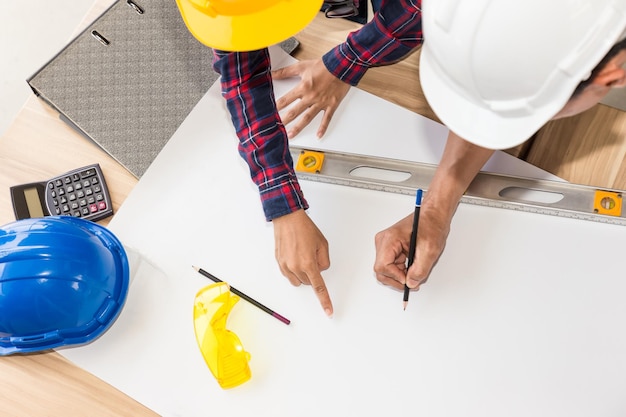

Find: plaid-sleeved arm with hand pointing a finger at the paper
<box><xmin>213</xmin><ymin>49</ymin><xmax>332</xmax><ymax>314</ymax></box>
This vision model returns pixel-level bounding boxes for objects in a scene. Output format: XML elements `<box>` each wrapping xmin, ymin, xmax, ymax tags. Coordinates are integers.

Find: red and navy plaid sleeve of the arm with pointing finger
<box><xmin>213</xmin><ymin>49</ymin><xmax>308</xmax><ymax>221</ymax></box>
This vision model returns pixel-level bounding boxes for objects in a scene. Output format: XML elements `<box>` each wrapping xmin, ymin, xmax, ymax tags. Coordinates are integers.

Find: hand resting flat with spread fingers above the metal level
<box><xmin>272</xmin><ymin>59</ymin><xmax>350</xmax><ymax>138</ymax></box>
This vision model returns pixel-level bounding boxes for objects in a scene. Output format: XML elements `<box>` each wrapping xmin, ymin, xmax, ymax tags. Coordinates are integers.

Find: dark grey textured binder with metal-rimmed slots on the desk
<box><xmin>27</xmin><ymin>0</ymin><xmax>298</xmax><ymax>178</ymax></box>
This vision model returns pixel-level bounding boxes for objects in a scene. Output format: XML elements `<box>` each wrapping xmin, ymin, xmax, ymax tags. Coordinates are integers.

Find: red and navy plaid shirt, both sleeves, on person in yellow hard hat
<box><xmin>214</xmin><ymin>0</ymin><xmax>422</xmax><ymax>221</ymax></box>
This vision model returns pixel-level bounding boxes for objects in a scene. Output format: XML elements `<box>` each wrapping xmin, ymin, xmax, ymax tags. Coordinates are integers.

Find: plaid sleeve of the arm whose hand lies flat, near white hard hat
<box><xmin>322</xmin><ymin>0</ymin><xmax>423</xmax><ymax>85</ymax></box>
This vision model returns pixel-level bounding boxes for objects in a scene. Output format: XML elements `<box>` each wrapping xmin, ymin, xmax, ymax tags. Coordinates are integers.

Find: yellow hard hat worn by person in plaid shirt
<box><xmin>176</xmin><ymin>0</ymin><xmax>323</xmax><ymax>52</ymax></box>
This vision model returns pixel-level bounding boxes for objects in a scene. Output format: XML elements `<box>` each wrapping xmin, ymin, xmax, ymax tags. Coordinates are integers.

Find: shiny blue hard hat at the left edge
<box><xmin>0</xmin><ymin>216</ymin><xmax>129</xmax><ymax>355</ymax></box>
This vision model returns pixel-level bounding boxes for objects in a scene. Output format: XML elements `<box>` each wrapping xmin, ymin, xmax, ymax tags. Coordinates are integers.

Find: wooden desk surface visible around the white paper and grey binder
<box><xmin>0</xmin><ymin>0</ymin><xmax>626</xmax><ymax>417</ymax></box>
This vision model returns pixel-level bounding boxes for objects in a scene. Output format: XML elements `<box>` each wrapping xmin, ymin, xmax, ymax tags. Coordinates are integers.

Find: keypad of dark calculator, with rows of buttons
<box><xmin>46</xmin><ymin>166</ymin><xmax>112</xmax><ymax>220</ymax></box>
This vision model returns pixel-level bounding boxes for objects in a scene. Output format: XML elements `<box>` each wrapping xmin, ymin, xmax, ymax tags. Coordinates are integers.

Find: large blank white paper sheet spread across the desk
<box><xmin>60</xmin><ymin>46</ymin><xmax>626</xmax><ymax>417</ymax></box>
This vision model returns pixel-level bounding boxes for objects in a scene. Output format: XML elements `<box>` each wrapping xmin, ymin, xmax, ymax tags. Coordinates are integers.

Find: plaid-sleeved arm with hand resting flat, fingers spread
<box><xmin>273</xmin><ymin>0</ymin><xmax>422</xmax><ymax>138</ymax></box>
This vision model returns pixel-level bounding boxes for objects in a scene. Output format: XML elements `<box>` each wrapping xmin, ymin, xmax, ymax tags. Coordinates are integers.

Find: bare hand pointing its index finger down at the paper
<box><xmin>272</xmin><ymin>210</ymin><xmax>333</xmax><ymax>317</ymax></box>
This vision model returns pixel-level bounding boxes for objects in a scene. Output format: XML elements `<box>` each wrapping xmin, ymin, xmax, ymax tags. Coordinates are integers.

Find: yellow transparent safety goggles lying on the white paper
<box><xmin>193</xmin><ymin>282</ymin><xmax>251</xmax><ymax>389</ymax></box>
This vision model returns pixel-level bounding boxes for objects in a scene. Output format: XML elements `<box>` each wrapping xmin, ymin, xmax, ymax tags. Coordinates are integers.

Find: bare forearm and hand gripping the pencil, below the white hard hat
<box><xmin>374</xmin><ymin>132</ymin><xmax>494</xmax><ymax>290</ymax></box>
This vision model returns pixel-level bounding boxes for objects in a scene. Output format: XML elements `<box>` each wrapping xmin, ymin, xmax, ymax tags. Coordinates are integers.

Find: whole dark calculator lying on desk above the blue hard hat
<box><xmin>11</xmin><ymin>164</ymin><xmax>113</xmax><ymax>221</ymax></box>
